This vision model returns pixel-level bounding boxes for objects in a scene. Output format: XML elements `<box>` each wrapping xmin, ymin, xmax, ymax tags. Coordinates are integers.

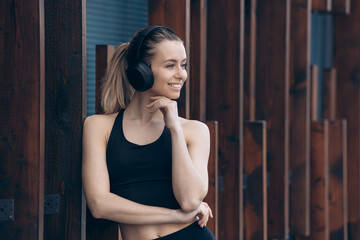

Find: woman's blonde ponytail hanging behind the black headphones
<box><xmin>101</xmin><ymin>43</ymin><xmax>135</xmax><ymax>114</ymax></box>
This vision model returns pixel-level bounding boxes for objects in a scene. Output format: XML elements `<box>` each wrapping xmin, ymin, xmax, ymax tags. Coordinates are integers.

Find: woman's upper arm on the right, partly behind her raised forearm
<box><xmin>186</xmin><ymin>121</ymin><xmax>210</xmax><ymax>184</ymax></box>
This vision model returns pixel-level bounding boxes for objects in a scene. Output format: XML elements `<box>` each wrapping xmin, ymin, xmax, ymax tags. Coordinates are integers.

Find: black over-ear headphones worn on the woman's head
<box><xmin>126</xmin><ymin>26</ymin><xmax>175</xmax><ymax>92</ymax></box>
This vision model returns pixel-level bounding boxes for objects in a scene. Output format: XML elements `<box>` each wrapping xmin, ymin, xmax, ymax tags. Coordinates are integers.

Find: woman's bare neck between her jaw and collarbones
<box><xmin>126</xmin><ymin>92</ymin><xmax>163</xmax><ymax>123</ymax></box>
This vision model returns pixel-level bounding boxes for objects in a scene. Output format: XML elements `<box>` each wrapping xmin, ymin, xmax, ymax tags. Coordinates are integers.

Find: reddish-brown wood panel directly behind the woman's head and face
<box><xmin>149</xmin><ymin>0</ymin><xmax>191</xmax><ymax>118</ymax></box>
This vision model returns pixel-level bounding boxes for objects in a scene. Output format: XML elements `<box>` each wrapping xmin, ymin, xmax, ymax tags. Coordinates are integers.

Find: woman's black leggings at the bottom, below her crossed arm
<box><xmin>154</xmin><ymin>221</ymin><xmax>216</xmax><ymax>240</ymax></box>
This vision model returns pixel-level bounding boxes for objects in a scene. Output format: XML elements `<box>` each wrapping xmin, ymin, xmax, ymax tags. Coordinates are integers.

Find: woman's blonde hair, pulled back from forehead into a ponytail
<box><xmin>101</xmin><ymin>28</ymin><xmax>182</xmax><ymax>114</ymax></box>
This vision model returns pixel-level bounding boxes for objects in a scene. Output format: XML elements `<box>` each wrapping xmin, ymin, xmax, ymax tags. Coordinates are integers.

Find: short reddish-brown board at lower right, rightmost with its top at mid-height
<box><xmin>329</xmin><ymin>120</ymin><xmax>348</xmax><ymax>240</ymax></box>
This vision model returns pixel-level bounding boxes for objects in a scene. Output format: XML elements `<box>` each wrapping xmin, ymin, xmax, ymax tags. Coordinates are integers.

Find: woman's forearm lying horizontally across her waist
<box><xmin>89</xmin><ymin>193</ymin><xmax>196</xmax><ymax>225</ymax></box>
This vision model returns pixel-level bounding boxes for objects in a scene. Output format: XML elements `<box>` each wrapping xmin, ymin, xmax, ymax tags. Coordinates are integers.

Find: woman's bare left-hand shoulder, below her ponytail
<box><xmin>84</xmin><ymin>113</ymin><xmax>118</xmax><ymax>140</ymax></box>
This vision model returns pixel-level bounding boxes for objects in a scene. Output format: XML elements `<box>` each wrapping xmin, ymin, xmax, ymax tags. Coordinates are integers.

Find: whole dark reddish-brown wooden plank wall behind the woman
<box><xmin>0</xmin><ymin>0</ymin><xmax>360</xmax><ymax>240</ymax></box>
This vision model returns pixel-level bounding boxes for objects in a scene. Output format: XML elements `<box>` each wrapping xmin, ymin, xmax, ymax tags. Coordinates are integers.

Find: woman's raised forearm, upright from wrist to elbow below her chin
<box><xmin>171</xmin><ymin>127</ymin><xmax>207</xmax><ymax>211</ymax></box>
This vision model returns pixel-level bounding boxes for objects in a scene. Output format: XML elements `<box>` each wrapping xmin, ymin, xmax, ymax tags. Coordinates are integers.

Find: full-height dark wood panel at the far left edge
<box><xmin>0</xmin><ymin>0</ymin><xmax>45</xmax><ymax>240</ymax></box>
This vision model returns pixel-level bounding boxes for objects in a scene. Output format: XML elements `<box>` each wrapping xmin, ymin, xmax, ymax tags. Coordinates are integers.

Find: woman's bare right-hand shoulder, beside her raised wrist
<box><xmin>180</xmin><ymin>118</ymin><xmax>210</xmax><ymax>140</ymax></box>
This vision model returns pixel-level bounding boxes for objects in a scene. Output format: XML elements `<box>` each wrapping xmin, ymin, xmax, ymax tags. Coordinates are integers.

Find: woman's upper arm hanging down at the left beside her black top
<box><xmin>82</xmin><ymin>116</ymin><xmax>110</xmax><ymax>208</ymax></box>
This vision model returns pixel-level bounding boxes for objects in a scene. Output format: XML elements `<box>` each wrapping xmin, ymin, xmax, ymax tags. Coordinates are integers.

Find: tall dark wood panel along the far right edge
<box><xmin>334</xmin><ymin>1</ymin><xmax>360</xmax><ymax>223</ymax></box>
